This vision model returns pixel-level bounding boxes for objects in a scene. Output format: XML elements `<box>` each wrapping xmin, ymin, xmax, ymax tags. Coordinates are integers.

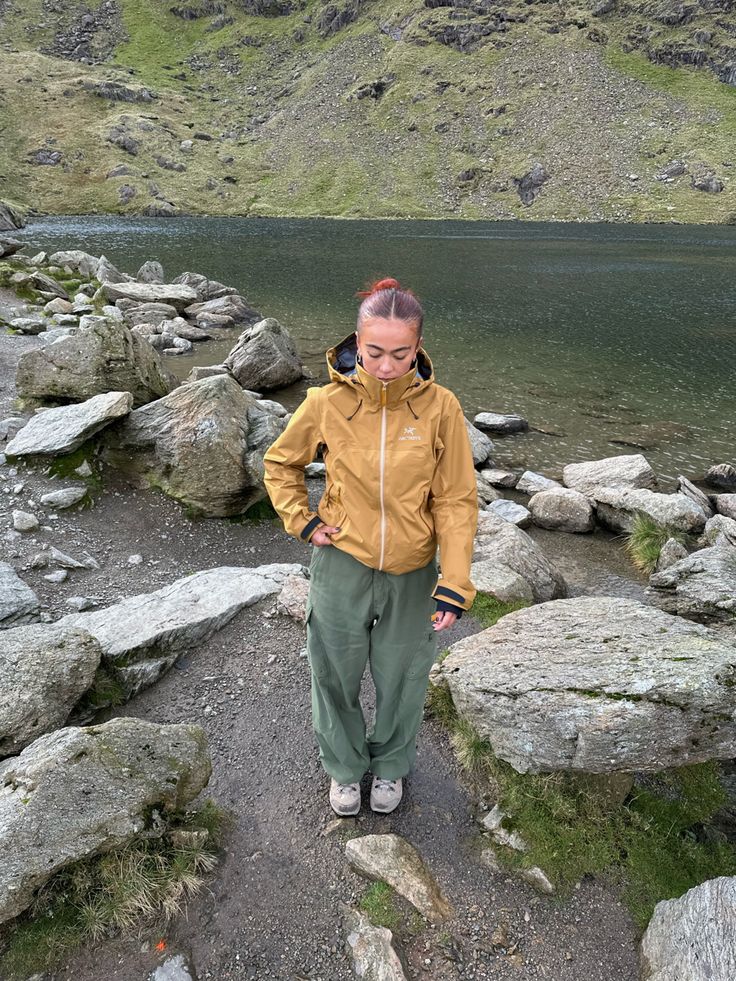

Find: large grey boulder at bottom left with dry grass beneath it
<box><xmin>0</xmin><ymin>719</ymin><xmax>212</xmax><ymax>923</ymax></box>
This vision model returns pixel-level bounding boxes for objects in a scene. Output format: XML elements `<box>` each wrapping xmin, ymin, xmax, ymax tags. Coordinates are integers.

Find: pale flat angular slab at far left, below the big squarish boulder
<box><xmin>5</xmin><ymin>392</ymin><xmax>133</xmax><ymax>457</ymax></box>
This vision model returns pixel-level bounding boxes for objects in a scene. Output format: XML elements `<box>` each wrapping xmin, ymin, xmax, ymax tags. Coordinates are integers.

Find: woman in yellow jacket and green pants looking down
<box><xmin>265</xmin><ymin>279</ymin><xmax>477</xmax><ymax>816</ymax></box>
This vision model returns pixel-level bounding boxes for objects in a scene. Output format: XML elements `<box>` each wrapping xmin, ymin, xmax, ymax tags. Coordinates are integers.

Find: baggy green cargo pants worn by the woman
<box><xmin>307</xmin><ymin>545</ymin><xmax>437</xmax><ymax>783</ymax></box>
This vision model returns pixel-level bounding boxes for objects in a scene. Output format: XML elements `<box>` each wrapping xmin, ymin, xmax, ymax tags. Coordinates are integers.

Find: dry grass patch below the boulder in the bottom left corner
<box><xmin>0</xmin><ymin>801</ymin><xmax>227</xmax><ymax>981</ymax></box>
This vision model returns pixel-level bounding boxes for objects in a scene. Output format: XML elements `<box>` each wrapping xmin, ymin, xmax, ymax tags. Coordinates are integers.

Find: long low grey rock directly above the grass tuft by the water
<box><xmin>590</xmin><ymin>487</ymin><xmax>706</xmax><ymax>533</ymax></box>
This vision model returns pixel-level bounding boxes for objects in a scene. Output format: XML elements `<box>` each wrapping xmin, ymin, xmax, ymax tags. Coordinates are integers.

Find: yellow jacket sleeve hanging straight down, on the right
<box><xmin>429</xmin><ymin>396</ymin><xmax>478</xmax><ymax>610</ymax></box>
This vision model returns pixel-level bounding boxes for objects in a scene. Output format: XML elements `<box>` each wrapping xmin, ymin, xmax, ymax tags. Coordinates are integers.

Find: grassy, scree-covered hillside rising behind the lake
<box><xmin>0</xmin><ymin>0</ymin><xmax>736</xmax><ymax>223</ymax></box>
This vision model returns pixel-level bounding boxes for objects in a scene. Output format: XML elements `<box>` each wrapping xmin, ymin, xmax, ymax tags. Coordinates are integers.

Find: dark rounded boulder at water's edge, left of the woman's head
<box><xmin>224</xmin><ymin>317</ymin><xmax>304</xmax><ymax>392</ymax></box>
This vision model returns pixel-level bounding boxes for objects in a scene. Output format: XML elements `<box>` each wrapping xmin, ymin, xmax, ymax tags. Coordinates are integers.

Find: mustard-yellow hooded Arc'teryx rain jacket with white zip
<box><xmin>264</xmin><ymin>334</ymin><xmax>478</xmax><ymax>610</ymax></box>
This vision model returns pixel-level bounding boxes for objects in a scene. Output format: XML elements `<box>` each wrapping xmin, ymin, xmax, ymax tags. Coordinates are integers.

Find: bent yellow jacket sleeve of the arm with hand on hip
<box><xmin>263</xmin><ymin>388</ymin><xmax>322</xmax><ymax>542</ymax></box>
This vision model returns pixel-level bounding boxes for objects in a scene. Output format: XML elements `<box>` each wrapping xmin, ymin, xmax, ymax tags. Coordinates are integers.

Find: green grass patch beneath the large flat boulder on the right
<box><xmin>427</xmin><ymin>672</ymin><xmax>736</xmax><ymax>928</ymax></box>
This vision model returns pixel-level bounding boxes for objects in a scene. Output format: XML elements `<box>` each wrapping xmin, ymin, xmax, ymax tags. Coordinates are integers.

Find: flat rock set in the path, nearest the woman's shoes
<box><xmin>345</xmin><ymin>834</ymin><xmax>453</xmax><ymax>923</ymax></box>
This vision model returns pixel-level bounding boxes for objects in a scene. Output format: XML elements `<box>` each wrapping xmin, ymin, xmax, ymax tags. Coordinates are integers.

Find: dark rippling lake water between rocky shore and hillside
<box><xmin>21</xmin><ymin>217</ymin><xmax>736</xmax><ymax>480</ymax></box>
